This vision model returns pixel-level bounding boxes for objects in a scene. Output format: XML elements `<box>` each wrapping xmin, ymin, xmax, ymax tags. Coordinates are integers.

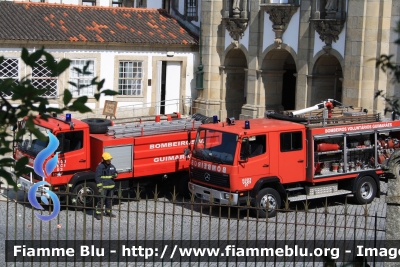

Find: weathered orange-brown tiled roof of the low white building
<box><xmin>0</xmin><ymin>1</ymin><xmax>199</xmax><ymax>45</ymax></box>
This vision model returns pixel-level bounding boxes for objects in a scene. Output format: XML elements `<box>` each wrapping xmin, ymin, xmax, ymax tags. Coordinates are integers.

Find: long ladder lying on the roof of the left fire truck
<box><xmin>107</xmin><ymin>119</ymin><xmax>202</xmax><ymax>138</ymax></box>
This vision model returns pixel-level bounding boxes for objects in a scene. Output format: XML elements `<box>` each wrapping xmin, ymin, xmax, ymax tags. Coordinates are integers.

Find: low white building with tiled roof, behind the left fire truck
<box><xmin>0</xmin><ymin>1</ymin><xmax>198</xmax><ymax>118</ymax></box>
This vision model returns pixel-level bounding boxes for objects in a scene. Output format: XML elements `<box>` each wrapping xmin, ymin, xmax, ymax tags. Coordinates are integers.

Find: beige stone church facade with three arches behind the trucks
<box><xmin>193</xmin><ymin>0</ymin><xmax>400</xmax><ymax>118</ymax></box>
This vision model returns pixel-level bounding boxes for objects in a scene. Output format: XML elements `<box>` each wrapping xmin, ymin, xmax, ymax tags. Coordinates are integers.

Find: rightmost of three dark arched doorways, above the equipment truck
<box><xmin>309</xmin><ymin>55</ymin><xmax>343</xmax><ymax>105</ymax></box>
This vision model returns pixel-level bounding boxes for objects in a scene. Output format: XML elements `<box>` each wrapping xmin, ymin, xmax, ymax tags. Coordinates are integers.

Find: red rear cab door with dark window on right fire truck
<box><xmin>278</xmin><ymin>131</ymin><xmax>307</xmax><ymax>183</ymax></box>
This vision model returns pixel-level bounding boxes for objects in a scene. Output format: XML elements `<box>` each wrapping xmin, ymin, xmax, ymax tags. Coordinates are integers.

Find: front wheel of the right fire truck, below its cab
<box><xmin>255</xmin><ymin>188</ymin><xmax>281</xmax><ymax>218</ymax></box>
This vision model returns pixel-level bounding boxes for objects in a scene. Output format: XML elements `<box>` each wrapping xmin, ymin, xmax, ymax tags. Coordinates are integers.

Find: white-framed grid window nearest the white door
<box><xmin>118</xmin><ymin>61</ymin><xmax>143</xmax><ymax>96</ymax></box>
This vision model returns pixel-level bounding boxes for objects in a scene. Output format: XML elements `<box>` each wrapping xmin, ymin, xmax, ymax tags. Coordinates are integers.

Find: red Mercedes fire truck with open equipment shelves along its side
<box><xmin>189</xmin><ymin>100</ymin><xmax>400</xmax><ymax>217</ymax></box>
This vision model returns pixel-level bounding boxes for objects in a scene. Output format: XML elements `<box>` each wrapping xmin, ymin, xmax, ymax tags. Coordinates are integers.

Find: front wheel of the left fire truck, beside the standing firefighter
<box><xmin>70</xmin><ymin>182</ymin><xmax>99</xmax><ymax>209</ymax></box>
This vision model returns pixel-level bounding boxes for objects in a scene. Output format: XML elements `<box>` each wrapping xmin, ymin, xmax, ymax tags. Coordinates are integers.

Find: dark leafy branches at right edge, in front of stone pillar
<box><xmin>375</xmin><ymin>21</ymin><xmax>400</xmax><ymax>115</ymax></box>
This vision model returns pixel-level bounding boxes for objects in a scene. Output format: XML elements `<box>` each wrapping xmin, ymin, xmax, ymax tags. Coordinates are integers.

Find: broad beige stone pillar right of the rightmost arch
<box><xmin>343</xmin><ymin>0</ymin><xmax>392</xmax><ymax>112</ymax></box>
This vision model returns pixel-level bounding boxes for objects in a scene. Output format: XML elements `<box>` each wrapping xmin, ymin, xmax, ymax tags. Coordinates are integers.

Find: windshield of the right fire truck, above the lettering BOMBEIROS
<box><xmin>193</xmin><ymin>130</ymin><xmax>238</xmax><ymax>165</ymax></box>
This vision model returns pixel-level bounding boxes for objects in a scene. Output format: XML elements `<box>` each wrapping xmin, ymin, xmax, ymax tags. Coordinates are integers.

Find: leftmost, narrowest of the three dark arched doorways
<box><xmin>222</xmin><ymin>49</ymin><xmax>247</xmax><ymax>118</ymax></box>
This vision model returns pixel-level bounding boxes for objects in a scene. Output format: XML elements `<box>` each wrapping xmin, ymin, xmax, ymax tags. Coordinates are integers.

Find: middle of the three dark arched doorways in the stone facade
<box><xmin>260</xmin><ymin>49</ymin><xmax>297</xmax><ymax>111</ymax></box>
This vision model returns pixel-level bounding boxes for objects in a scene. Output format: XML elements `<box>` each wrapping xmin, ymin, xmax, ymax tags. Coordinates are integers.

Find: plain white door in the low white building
<box><xmin>165</xmin><ymin>61</ymin><xmax>181</xmax><ymax>114</ymax></box>
